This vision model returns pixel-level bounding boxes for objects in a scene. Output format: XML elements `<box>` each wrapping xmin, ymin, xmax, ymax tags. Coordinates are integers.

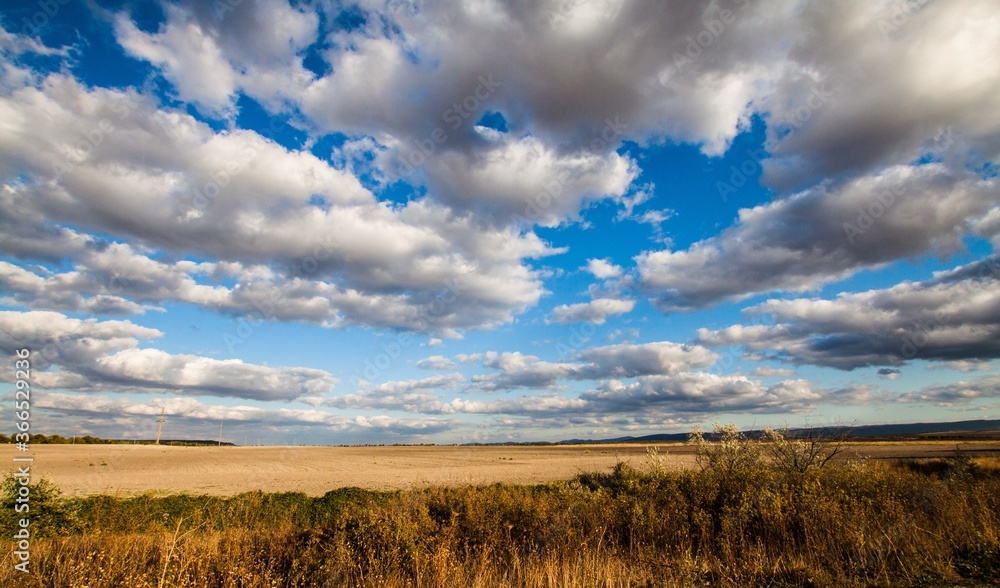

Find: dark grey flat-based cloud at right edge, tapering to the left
<box><xmin>698</xmin><ymin>256</ymin><xmax>1000</xmax><ymax>370</ymax></box>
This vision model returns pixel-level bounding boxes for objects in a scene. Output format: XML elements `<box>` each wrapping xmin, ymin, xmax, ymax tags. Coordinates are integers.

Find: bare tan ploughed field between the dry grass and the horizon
<box><xmin>0</xmin><ymin>441</ymin><xmax>1000</xmax><ymax>495</ymax></box>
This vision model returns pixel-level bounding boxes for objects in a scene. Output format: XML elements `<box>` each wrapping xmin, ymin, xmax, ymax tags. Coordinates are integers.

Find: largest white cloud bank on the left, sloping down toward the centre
<box><xmin>0</xmin><ymin>75</ymin><xmax>551</xmax><ymax>331</ymax></box>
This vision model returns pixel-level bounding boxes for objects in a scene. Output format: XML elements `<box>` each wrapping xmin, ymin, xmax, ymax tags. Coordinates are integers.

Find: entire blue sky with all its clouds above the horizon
<box><xmin>0</xmin><ymin>0</ymin><xmax>1000</xmax><ymax>445</ymax></box>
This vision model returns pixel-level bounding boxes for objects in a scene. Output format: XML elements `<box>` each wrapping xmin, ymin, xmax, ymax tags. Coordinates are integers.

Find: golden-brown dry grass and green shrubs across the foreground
<box><xmin>0</xmin><ymin>457</ymin><xmax>1000</xmax><ymax>588</ymax></box>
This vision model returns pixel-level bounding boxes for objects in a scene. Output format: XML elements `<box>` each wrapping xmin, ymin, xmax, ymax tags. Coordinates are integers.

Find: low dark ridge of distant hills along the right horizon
<box><xmin>558</xmin><ymin>420</ymin><xmax>1000</xmax><ymax>445</ymax></box>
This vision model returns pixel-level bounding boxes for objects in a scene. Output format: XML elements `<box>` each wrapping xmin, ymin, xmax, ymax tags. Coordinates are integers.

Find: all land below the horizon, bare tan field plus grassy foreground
<box><xmin>0</xmin><ymin>434</ymin><xmax>1000</xmax><ymax>588</ymax></box>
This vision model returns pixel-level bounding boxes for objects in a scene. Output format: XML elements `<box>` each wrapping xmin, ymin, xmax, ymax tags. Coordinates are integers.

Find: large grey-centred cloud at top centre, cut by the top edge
<box><xmin>303</xmin><ymin>1</ymin><xmax>794</xmax><ymax>153</ymax></box>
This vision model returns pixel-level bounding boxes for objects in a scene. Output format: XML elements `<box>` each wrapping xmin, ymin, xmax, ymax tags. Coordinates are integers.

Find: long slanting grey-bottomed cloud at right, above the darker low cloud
<box><xmin>636</xmin><ymin>164</ymin><xmax>998</xmax><ymax>311</ymax></box>
